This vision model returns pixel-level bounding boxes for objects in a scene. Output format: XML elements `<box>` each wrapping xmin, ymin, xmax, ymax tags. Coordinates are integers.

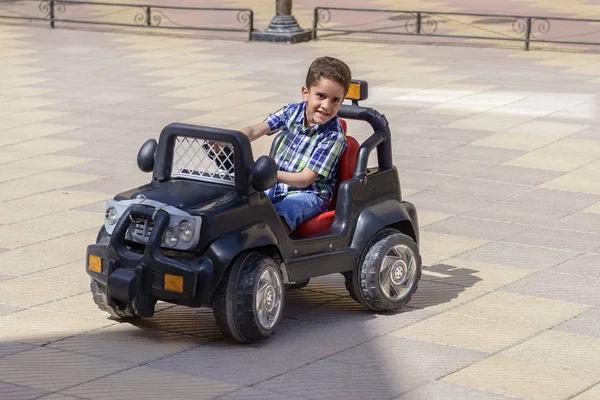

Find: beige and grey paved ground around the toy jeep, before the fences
<box><xmin>0</xmin><ymin>17</ymin><xmax>600</xmax><ymax>400</ymax></box>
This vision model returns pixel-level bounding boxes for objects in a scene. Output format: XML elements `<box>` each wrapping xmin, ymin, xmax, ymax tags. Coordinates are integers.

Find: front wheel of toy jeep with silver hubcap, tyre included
<box><xmin>213</xmin><ymin>252</ymin><xmax>284</xmax><ymax>343</ymax></box>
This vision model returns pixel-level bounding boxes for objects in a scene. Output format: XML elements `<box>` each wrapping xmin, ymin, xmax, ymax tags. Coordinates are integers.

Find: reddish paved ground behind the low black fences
<box><xmin>0</xmin><ymin>0</ymin><xmax>600</xmax><ymax>51</ymax></box>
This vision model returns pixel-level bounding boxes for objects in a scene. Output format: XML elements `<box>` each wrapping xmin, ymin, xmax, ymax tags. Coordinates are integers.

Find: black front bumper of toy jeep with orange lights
<box><xmin>86</xmin><ymin>205</ymin><xmax>213</xmax><ymax>316</ymax></box>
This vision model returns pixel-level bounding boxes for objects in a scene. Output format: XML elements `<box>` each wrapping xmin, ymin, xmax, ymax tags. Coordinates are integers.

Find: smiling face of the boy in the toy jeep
<box><xmin>302</xmin><ymin>78</ymin><xmax>346</xmax><ymax>126</ymax></box>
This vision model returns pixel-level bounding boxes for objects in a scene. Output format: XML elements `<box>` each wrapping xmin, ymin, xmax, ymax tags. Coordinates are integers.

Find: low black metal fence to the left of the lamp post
<box><xmin>0</xmin><ymin>0</ymin><xmax>254</xmax><ymax>40</ymax></box>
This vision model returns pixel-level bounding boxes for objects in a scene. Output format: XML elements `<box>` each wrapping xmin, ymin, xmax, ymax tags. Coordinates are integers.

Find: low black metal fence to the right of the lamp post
<box><xmin>313</xmin><ymin>7</ymin><xmax>600</xmax><ymax>50</ymax></box>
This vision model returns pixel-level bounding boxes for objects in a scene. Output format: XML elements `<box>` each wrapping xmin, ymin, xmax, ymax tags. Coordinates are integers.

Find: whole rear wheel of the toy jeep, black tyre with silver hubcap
<box><xmin>346</xmin><ymin>229</ymin><xmax>421</xmax><ymax>311</ymax></box>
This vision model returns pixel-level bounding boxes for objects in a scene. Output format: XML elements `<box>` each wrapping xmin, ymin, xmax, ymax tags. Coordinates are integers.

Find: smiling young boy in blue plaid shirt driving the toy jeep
<box><xmin>240</xmin><ymin>57</ymin><xmax>351</xmax><ymax>234</ymax></box>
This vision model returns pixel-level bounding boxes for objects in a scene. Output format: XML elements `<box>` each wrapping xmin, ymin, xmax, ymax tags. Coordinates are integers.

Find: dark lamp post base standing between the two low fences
<box><xmin>252</xmin><ymin>0</ymin><xmax>312</xmax><ymax>43</ymax></box>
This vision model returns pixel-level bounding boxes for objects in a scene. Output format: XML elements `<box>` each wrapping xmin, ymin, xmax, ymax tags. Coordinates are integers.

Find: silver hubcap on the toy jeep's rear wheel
<box><xmin>379</xmin><ymin>244</ymin><xmax>417</xmax><ymax>301</ymax></box>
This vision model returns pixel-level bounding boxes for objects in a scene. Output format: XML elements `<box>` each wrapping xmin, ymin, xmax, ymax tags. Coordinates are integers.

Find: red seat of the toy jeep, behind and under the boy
<box><xmin>293</xmin><ymin>118</ymin><xmax>360</xmax><ymax>237</ymax></box>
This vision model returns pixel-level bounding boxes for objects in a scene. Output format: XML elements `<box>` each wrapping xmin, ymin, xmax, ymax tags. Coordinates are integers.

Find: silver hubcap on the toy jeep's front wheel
<box><xmin>254</xmin><ymin>267</ymin><xmax>283</xmax><ymax>329</ymax></box>
